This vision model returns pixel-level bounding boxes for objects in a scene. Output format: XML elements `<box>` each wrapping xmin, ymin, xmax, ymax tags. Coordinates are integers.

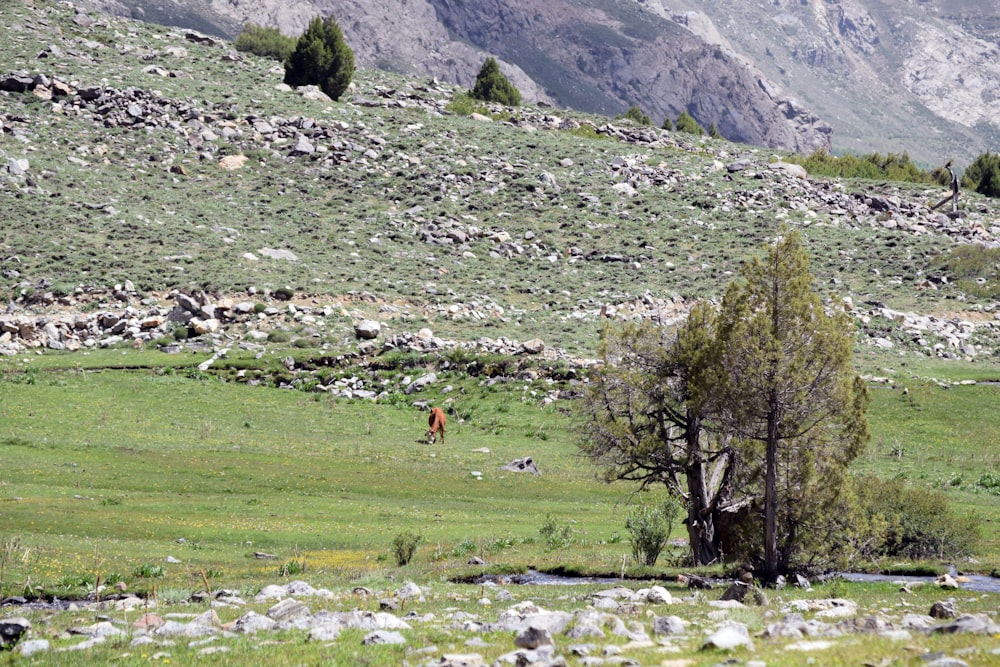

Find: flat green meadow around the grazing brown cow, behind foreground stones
<box><xmin>0</xmin><ymin>350</ymin><xmax>1000</xmax><ymax>594</ymax></box>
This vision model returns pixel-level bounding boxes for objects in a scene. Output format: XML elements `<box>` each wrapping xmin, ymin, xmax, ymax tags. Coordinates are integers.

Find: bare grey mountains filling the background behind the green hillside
<box><xmin>78</xmin><ymin>0</ymin><xmax>1000</xmax><ymax>165</ymax></box>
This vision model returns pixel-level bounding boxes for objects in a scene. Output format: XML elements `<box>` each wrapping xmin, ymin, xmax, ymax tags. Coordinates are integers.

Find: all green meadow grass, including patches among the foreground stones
<box><xmin>0</xmin><ymin>350</ymin><xmax>1000</xmax><ymax>667</ymax></box>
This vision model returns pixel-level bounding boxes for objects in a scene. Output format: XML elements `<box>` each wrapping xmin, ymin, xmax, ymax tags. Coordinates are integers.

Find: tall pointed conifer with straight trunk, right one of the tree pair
<box><xmin>718</xmin><ymin>232</ymin><xmax>868</xmax><ymax>581</ymax></box>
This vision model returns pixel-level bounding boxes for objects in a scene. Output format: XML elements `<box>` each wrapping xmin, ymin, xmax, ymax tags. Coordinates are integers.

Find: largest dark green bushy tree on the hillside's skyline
<box><xmin>285</xmin><ymin>16</ymin><xmax>354</xmax><ymax>100</ymax></box>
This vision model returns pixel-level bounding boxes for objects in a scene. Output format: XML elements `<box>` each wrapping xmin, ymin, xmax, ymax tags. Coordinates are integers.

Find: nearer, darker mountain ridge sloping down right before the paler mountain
<box><xmin>74</xmin><ymin>0</ymin><xmax>830</xmax><ymax>151</ymax></box>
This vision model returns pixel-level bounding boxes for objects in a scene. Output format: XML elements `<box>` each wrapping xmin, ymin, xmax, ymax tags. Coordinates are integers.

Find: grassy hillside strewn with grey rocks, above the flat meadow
<box><xmin>0</xmin><ymin>3</ymin><xmax>1000</xmax><ymax>366</ymax></box>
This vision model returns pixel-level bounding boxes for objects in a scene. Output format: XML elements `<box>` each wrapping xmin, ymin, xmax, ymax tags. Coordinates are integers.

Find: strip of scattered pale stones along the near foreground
<box><xmin>0</xmin><ymin>581</ymin><xmax>1000</xmax><ymax>667</ymax></box>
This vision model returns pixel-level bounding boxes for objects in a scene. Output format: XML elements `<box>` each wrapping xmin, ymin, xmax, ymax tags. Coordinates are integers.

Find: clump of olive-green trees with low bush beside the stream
<box><xmin>580</xmin><ymin>232</ymin><xmax>976</xmax><ymax>581</ymax></box>
